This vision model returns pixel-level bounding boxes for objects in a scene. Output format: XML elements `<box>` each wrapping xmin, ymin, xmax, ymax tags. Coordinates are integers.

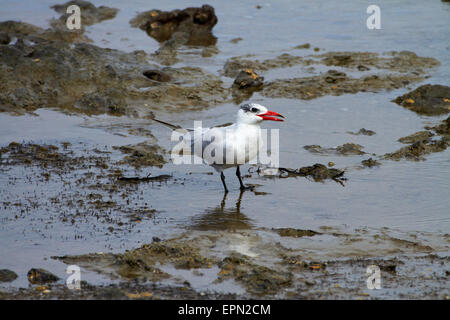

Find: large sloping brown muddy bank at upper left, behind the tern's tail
<box><xmin>0</xmin><ymin>21</ymin><xmax>231</xmax><ymax>117</ymax></box>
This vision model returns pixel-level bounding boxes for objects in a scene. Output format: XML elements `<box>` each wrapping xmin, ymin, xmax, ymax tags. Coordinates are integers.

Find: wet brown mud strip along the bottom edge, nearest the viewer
<box><xmin>0</xmin><ymin>227</ymin><xmax>450</xmax><ymax>299</ymax></box>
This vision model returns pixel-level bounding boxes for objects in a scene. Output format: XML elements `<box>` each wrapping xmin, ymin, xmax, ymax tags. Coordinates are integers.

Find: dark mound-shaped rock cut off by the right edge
<box><xmin>393</xmin><ymin>84</ymin><xmax>450</xmax><ymax>116</ymax></box>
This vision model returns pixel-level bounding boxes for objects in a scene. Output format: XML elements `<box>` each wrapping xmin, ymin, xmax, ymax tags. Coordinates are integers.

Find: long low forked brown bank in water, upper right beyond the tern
<box><xmin>256</xmin><ymin>51</ymin><xmax>439</xmax><ymax>100</ymax></box>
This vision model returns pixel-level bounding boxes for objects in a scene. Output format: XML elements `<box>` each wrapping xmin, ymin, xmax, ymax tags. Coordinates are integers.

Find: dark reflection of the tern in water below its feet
<box><xmin>191</xmin><ymin>191</ymin><xmax>253</xmax><ymax>231</ymax></box>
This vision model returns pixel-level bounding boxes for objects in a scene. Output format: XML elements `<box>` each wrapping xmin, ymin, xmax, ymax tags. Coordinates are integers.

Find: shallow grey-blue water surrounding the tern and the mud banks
<box><xmin>0</xmin><ymin>0</ymin><xmax>450</xmax><ymax>296</ymax></box>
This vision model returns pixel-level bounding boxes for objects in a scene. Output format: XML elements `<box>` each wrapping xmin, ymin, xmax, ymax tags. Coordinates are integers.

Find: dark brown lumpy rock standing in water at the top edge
<box><xmin>130</xmin><ymin>5</ymin><xmax>217</xmax><ymax>46</ymax></box>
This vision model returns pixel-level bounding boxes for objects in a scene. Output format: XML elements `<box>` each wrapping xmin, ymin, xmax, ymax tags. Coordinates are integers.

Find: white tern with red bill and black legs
<box><xmin>153</xmin><ymin>103</ymin><xmax>284</xmax><ymax>193</ymax></box>
